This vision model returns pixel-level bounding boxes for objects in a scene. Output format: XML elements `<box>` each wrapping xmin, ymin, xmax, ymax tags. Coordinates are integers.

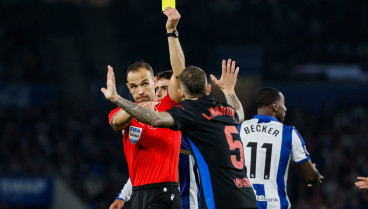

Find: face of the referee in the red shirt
<box><xmin>126</xmin><ymin>68</ymin><xmax>155</xmax><ymax>103</ymax></box>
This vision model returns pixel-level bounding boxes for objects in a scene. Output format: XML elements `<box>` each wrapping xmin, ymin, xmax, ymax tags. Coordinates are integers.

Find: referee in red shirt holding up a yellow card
<box><xmin>108</xmin><ymin>7</ymin><xmax>185</xmax><ymax>209</ymax></box>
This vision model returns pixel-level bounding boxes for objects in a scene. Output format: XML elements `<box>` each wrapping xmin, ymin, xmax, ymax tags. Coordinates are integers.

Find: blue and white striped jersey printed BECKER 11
<box><xmin>239</xmin><ymin>115</ymin><xmax>309</xmax><ymax>209</ymax></box>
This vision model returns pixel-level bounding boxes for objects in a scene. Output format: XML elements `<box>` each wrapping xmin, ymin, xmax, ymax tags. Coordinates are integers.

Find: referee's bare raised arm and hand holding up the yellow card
<box><xmin>164</xmin><ymin>7</ymin><xmax>185</xmax><ymax>102</ymax></box>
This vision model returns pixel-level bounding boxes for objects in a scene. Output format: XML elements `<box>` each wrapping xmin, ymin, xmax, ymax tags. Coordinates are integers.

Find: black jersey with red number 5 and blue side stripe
<box><xmin>167</xmin><ymin>96</ymin><xmax>257</xmax><ymax>209</ymax></box>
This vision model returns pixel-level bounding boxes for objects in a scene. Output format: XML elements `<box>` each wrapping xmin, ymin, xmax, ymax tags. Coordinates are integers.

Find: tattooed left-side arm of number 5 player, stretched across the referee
<box><xmin>101</xmin><ymin>66</ymin><xmax>175</xmax><ymax>128</ymax></box>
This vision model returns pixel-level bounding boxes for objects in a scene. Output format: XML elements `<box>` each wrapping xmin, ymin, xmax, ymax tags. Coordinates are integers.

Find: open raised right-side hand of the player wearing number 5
<box><xmin>210</xmin><ymin>59</ymin><xmax>239</xmax><ymax>94</ymax></box>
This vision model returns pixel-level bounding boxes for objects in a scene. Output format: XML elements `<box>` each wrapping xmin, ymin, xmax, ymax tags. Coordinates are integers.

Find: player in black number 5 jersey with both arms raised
<box><xmin>101</xmin><ymin>60</ymin><xmax>258</xmax><ymax>209</ymax></box>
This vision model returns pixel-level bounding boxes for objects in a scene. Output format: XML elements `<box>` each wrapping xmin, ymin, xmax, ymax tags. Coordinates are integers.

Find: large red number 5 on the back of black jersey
<box><xmin>225</xmin><ymin>126</ymin><xmax>244</xmax><ymax>169</ymax></box>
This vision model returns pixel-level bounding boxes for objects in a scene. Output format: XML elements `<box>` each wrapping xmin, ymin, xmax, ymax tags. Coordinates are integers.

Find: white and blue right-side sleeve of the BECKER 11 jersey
<box><xmin>291</xmin><ymin>128</ymin><xmax>310</xmax><ymax>164</ymax></box>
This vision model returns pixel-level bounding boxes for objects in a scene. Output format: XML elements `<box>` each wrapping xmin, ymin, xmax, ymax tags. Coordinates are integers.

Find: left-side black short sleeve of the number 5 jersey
<box><xmin>167</xmin><ymin>101</ymin><xmax>197</xmax><ymax>131</ymax></box>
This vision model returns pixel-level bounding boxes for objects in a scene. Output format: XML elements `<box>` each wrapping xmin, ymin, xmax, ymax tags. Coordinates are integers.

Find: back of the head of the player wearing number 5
<box><xmin>179</xmin><ymin>66</ymin><xmax>207</xmax><ymax>97</ymax></box>
